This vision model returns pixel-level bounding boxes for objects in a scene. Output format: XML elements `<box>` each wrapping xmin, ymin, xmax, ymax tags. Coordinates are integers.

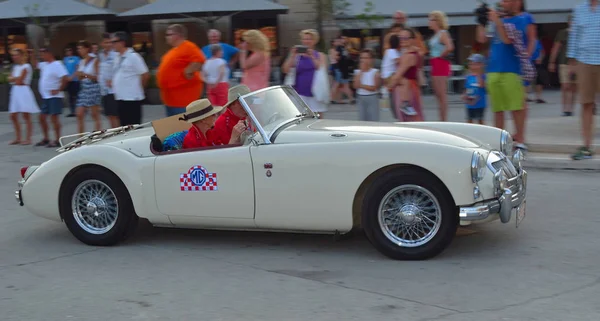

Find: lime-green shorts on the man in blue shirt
<box><xmin>486</xmin><ymin>72</ymin><xmax>525</xmax><ymax>113</ymax></box>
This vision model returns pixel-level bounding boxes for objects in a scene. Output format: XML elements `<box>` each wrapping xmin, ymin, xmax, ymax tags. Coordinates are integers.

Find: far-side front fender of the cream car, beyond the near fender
<box><xmin>394</xmin><ymin>122</ymin><xmax>502</xmax><ymax>150</ymax></box>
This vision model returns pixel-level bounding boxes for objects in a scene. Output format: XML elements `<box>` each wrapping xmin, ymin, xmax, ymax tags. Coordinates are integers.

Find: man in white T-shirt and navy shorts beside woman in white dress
<box><xmin>32</xmin><ymin>48</ymin><xmax>69</xmax><ymax>148</ymax></box>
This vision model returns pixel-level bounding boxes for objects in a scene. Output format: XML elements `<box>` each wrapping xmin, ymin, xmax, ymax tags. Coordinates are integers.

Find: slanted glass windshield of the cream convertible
<box><xmin>242</xmin><ymin>86</ymin><xmax>314</xmax><ymax>137</ymax></box>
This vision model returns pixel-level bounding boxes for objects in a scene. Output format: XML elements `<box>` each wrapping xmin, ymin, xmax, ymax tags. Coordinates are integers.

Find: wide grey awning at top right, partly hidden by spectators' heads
<box><xmin>336</xmin><ymin>0</ymin><xmax>574</xmax><ymax>29</ymax></box>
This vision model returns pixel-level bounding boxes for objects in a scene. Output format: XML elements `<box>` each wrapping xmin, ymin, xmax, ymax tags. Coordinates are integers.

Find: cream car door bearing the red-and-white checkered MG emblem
<box><xmin>154</xmin><ymin>146</ymin><xmax>254</xmax><ymax>219</ymax></box>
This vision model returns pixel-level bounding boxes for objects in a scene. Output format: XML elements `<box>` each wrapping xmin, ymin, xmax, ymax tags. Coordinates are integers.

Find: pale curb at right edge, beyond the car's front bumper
<box><xmin>523</xmin><ymin>153</ymin><xmax>600</xmax><ymax>172</ymax></box>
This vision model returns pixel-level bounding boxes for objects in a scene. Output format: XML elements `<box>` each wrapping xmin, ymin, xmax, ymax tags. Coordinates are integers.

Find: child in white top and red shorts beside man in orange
<box><xmin>202</xmin><ymin>44</ymin><xmax>229</xmax><ymax>106</ymax></box>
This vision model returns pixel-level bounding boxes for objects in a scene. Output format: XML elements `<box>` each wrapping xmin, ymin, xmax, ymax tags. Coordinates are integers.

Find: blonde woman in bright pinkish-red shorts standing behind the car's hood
<box><xmin>429</xmin><ymin>11</ymin><xmax>454</xmax><ymax>121</ymax></box>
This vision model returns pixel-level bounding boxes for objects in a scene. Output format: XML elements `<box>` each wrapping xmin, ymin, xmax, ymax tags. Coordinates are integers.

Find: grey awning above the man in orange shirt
<box><xmin>118</xmin><ymin>0</ymin><xmax>288</xmax><ymax>19</ymax></box>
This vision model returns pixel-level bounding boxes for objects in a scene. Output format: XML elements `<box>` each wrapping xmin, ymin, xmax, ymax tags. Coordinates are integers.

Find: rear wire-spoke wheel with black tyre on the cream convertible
<box><xmin>60</xmin><ymin>167</ymin><xmax>138</xmax><ymax>246</ymax></box>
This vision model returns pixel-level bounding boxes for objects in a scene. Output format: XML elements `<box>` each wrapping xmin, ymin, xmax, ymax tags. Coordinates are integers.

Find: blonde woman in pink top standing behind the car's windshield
<box><xmin>240</xmin><ymin>29</ymin><xmax>271</xmax><ymax>91</ymax></box>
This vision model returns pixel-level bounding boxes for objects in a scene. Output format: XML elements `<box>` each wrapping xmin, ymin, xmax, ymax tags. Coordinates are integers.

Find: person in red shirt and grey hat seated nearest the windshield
<box><xmin>212</xmin><ymin>85</ymin><xmax>250</xmax><ymax>144</ymax></box>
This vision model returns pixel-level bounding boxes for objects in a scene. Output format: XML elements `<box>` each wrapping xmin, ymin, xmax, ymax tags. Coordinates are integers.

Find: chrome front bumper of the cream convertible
<box><xmin>459</xmin><ymin>170</ymin><xmax>527</xmax><ymax>223</ymax></box>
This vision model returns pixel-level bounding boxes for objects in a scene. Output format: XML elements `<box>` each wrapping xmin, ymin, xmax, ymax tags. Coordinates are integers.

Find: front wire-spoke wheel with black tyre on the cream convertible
<box><xmin>362</xmin><ymin>168</ymin><xmax>459</xmax><ymax>260</ymax></box>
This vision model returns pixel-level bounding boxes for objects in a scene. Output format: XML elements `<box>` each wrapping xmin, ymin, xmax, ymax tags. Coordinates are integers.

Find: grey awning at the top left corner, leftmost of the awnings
<box><xmin>0</xmin><ymin>0</ymin><xmax>116</xmax><ymax>24</ymax></box>
